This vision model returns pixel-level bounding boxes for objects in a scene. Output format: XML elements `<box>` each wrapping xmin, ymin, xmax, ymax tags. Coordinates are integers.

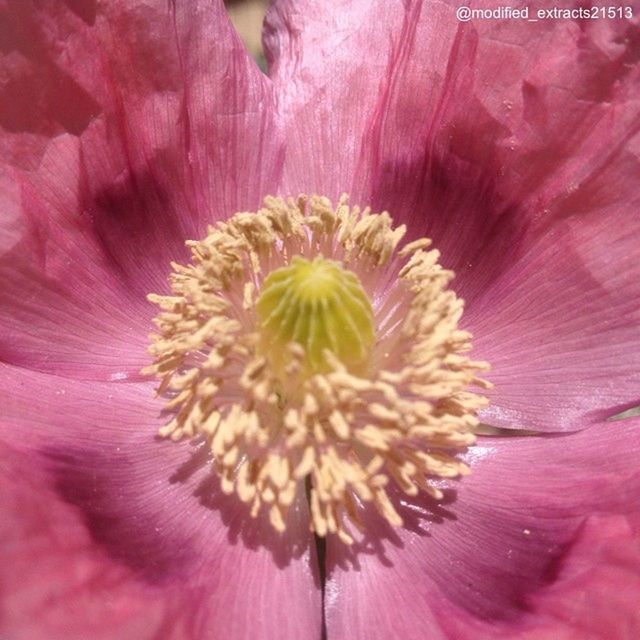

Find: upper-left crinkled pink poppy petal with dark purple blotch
<box><xmin>0</xmin><ymin>0</ymin><xmax>281</xmax><ymax>379</ymax></box>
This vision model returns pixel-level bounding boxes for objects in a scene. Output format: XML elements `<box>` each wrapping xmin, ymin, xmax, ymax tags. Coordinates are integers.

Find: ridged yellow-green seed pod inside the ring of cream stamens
<box><xmin>256</xmin><ymin>256</ymin><xmax>375</xmax><ymax>373</ymax></box>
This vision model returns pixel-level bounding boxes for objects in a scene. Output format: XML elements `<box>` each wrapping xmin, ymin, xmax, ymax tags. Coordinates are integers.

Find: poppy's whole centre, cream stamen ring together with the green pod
<box><xmin>145</xmin><ymin>196</ymin><xmax>488</xmax><ymax>543</ymax></box>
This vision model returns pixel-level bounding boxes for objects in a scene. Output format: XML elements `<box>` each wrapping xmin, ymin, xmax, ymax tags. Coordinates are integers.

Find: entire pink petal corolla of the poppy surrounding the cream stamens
<box><xmin>0</xmin><ymin>0</ymin><xmax>640</xmax><ymax>640</ymax></box>
